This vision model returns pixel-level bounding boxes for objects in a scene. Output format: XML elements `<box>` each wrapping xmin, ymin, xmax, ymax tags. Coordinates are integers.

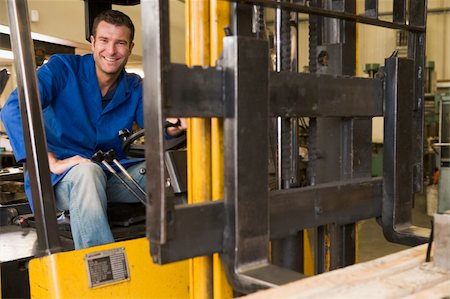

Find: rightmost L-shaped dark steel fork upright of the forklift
<box><xmin>382</xmin><ymin>57</ymin><xmax>429</xmax><ymax>246</ymax></box>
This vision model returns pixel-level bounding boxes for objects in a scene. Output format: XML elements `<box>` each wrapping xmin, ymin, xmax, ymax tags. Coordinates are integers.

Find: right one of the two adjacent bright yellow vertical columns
<box><xmin>210</xmin><ymin>0</ymin><xmax>233</xmax><ymax>299</ymax></box>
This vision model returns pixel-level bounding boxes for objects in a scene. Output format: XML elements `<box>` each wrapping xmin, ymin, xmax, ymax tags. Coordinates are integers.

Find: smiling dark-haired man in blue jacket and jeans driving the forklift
<box><xmin>1</xmin><ymin>10</ymin><xmax>181</xmax><ymax>249</ymax></box>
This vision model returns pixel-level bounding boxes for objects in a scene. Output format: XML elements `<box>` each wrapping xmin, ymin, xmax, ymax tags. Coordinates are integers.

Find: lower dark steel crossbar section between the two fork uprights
<box><xmin>270</xmin><ymin>178</ymin><xmax>383</xmax><ymax>238</ymax></box>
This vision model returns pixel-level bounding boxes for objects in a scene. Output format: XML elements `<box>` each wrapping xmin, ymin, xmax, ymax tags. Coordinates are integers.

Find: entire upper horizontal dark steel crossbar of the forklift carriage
<box><xmin>164</xmin><ymin>64</ymin><xmax>384</xmax><ymax>117</ymax></box>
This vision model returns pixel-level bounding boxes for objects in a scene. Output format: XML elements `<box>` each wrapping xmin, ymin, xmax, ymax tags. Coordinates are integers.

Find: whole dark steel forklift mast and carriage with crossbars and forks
<box><xmin>141</xmin><ymin>0</ymin><xmax>430</xmax><ymax>293</ymax></box>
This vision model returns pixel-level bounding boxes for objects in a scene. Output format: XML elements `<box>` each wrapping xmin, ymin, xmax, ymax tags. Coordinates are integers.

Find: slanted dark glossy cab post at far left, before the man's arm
<box><xmin>7</xmin><ymin>0</ymin><xmax>62</xmax><ymax>255</ymax></box>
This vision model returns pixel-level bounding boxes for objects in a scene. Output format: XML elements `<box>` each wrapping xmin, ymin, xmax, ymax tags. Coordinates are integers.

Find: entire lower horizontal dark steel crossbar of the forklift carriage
<box><xmin>151</xmin><ymin>178</ymin><xmax>383</xmax><ymax>264</ymax></box>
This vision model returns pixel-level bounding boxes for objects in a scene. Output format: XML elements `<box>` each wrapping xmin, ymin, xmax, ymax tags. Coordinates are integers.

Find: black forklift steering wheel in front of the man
<box><xmin>118</xmin><ymin>125</ymin><xmax>186</xmax><ymax>158</ymax></box>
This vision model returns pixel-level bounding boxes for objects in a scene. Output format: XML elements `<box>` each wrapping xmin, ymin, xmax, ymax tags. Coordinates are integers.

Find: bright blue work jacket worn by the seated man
<box><xmin>0</xmin><ymin>54</ymin><xmax>144</xmax><ymax>210</ymax></box>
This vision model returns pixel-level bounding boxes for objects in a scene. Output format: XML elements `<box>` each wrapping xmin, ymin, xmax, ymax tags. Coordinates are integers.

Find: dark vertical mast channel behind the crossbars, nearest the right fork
<box><xmin>312</xmin><ymin>0</ymin><xmax>358</xmax><ymax>273</ymax></box>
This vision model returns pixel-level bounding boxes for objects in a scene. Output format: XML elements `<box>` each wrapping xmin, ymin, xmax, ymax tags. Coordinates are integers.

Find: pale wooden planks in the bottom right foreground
<box><xmin>247</xmin><ymin>244</ymin><xmax>450</xmax><ymax>299</ymax></box>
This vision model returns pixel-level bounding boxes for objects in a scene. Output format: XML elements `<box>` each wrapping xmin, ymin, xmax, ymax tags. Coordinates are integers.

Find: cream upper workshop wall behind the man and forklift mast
<box><xmin>0</xmin><ymin>0</ymin><xmax>450</xmax><ymax>80</ymax></box>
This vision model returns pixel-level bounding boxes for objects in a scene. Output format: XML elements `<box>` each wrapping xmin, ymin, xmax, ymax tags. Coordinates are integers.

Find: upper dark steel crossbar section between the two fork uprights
<box><xmin>270</xmin><ymin>72</ymin><xmax>383</xmax><ymax>117</ymax></box>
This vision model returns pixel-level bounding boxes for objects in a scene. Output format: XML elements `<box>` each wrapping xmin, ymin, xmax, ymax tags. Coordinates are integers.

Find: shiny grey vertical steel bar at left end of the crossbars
<box><xmin>141</xmin><ymin>0</ymin><xmax>170</xmax><ymax>253</ymax></box>
